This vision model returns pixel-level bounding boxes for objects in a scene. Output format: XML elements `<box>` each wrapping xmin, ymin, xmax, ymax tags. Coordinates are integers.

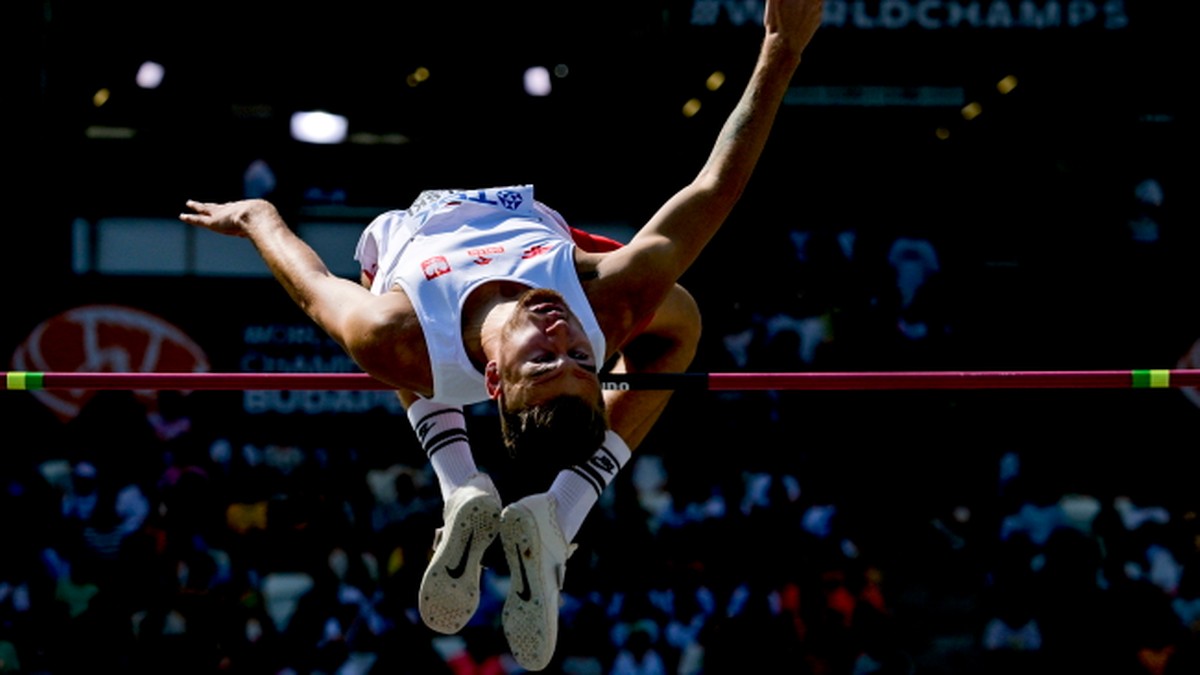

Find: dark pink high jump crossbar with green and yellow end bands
<box><xmin>2</xmin><ymin>369</ymin><xmax>1200</xmax><ymax>392</ymax></box>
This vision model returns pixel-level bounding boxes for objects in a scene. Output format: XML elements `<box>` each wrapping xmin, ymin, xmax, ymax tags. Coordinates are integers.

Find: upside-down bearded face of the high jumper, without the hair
<box><xmin>487</xmin><ymin>288</ymin><xmax>600</xmax><ymax>410</ymax></box>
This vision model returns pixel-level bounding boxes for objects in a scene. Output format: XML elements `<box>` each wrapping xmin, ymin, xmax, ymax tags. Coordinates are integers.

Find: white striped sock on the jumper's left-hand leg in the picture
<box><xmin>408</xmin><ymin>399</ymin><xmax>479</xmax><ymax>501</ymax></box>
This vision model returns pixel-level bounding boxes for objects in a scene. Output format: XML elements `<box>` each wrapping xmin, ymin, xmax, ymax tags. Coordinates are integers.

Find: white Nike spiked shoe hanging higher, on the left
<box><xmin>416</xmin><ymin>473</ymin><xmax>500</xmax><ymax>634</ymax></box>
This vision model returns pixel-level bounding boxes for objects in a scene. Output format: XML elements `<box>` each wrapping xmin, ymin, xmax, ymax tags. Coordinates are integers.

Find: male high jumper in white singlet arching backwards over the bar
<box><xmin>180</xmin><ymin>0</ymin><xmax>823</xmax><ymax>670</ymax></box>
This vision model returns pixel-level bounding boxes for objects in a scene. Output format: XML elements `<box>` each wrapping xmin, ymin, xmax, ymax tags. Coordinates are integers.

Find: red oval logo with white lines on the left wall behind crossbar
<box><xmin>12</xmin><ymin>305</ymin><xmax>210</xmax><ymax>422</ymax></box>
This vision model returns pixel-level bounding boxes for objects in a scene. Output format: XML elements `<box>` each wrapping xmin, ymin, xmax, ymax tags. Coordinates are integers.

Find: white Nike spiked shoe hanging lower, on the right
<box><xmin>500</xmin><ymin>494</ymin><xmax>575</xmax><ymax>670</ymax></box>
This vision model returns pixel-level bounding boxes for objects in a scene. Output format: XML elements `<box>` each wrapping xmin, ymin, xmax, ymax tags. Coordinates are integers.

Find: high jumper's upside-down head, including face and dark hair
<box><xmin>485</xmin><ymin>283</ymin><xmax>607</xmax><ymax>461</ymax></box>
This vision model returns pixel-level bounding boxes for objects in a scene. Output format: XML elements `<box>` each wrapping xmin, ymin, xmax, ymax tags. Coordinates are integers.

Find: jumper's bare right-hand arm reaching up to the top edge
<box><xmin>598</xmin><ymin>0</ymin><xmax>824</xmax><ymax>319</ymax></box>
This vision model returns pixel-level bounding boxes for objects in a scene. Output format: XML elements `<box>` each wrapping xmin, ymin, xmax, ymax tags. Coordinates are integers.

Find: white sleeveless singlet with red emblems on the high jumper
<box><xmin>354</xmin><ymin>185</ymin><xmax>605</xmax><ymax>406</ymax></box>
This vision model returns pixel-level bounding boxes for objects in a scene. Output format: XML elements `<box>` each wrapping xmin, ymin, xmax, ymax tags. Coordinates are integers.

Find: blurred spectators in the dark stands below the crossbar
<box><xmin>0</xmin><ymin>357</ymin><xmax>1200</xmax><ymax>675</ymax></box>
